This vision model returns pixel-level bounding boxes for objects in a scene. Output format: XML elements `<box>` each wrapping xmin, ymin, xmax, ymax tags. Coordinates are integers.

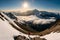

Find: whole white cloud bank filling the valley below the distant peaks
<box><xmin>18</xmin><ymin>15</ymin><xmax>56</xmax><ymax>24</ymax></box>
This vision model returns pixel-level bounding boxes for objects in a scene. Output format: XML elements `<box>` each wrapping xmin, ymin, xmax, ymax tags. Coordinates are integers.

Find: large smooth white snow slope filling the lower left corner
<box><xmin>0</xmin><ymin>19</ymin><xmax>19</xmax><ymax>40</ymax></box>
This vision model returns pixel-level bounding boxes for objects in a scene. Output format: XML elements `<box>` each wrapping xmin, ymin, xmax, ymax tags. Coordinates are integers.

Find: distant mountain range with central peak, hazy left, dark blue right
<box><xmin>11</xmin><ymin>9</ymin><xmax>60</xmax><ymax>19</ymax></box>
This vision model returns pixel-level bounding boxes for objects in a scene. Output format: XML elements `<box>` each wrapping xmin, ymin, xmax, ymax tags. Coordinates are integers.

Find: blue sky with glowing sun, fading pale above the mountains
<box><xmin>0</xmin><ymin>0</ymin><xmax>60</xmax><ymax>12</ymax></box>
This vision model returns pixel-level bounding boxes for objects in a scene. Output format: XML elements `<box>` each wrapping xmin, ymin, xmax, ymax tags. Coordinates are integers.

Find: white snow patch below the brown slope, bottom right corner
<box><xmin>41</xmin><ymin>32</ymin><xmax>60</xmax><ymax>40</ymax></box>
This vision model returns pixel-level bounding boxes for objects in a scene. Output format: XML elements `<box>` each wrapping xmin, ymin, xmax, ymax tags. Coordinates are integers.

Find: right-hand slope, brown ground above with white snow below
<box><xmin>41</xmin><ymin>20</ymin><xmax>60</xmax><ymax>40</ymax></box>
